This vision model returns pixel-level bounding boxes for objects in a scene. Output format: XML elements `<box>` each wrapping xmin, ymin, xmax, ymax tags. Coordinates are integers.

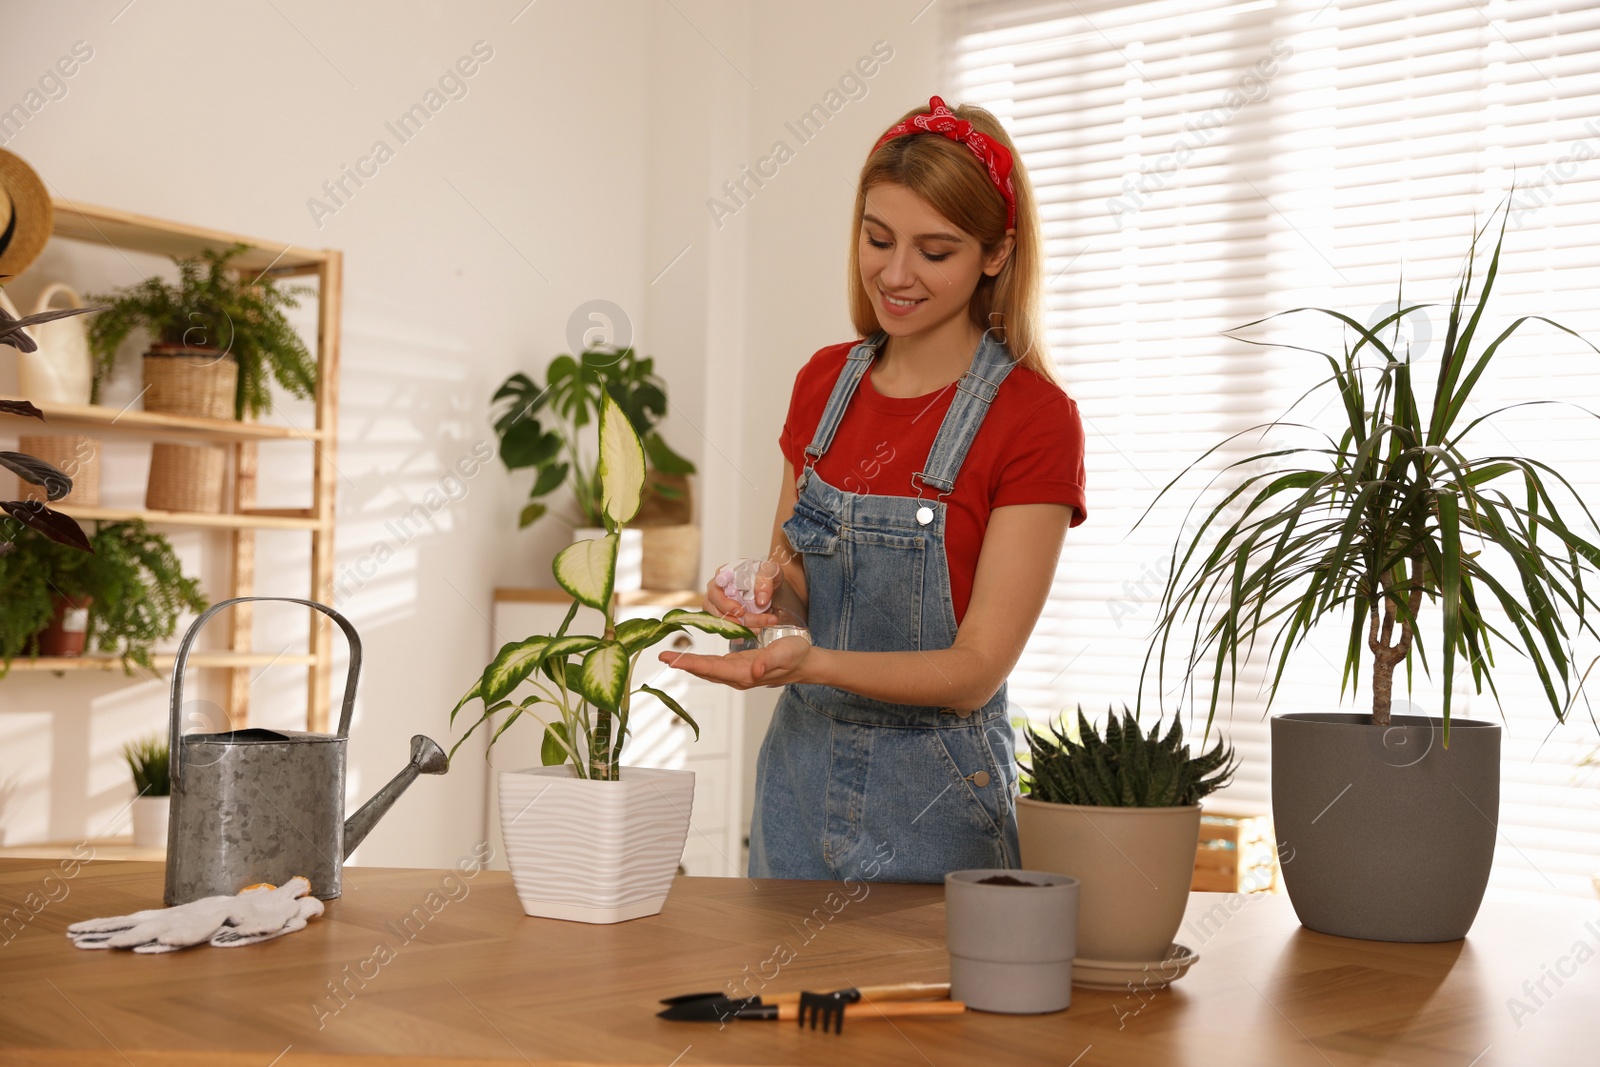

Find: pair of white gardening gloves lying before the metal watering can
<box><xmin>67</xmin><ymin>878</ymin><xmax>322</xmax><ymax>953</ymax></box>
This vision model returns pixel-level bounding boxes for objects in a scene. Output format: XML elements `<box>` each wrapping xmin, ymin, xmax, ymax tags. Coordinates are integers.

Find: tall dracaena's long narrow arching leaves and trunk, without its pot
<box><xmin>1146</xmin><ymin>202</ymin><xmax>1600</xmax><ymax>744</ymax></box>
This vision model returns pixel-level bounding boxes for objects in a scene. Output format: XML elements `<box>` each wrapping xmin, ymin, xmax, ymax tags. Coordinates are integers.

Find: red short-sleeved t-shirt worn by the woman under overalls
<box><xmin>778</xmin><ymin>341</ymin><xmax>1085</xmax><ymax>622</ymax></box>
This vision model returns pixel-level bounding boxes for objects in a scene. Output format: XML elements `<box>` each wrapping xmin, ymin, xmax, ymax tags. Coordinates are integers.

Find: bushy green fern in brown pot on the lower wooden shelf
<box><xmin>0</xmin><ymin>520</ymin><xmax>206</xmax><ymax>677</ymax></box>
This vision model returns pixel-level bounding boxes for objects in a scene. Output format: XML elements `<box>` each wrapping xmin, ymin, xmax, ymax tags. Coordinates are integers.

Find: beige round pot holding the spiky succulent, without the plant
<box><xmin>1016</xmin><ymin>797</ymin><xmax>1200</xmax><ymax>961</ymax></box>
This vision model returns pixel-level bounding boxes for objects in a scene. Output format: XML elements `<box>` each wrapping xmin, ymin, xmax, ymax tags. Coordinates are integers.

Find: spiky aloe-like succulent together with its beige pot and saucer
<box><xmin>1016</xmin><ymin>709</ymin><xmax>1237</xmax><ymax>989</ymax></box>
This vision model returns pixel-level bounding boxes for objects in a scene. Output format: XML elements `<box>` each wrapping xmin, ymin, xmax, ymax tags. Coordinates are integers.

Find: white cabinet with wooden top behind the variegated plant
<box><xmin>483</xmin><ymin>589</ymin><xmax>746</xmax><ymax>877</ymax></box>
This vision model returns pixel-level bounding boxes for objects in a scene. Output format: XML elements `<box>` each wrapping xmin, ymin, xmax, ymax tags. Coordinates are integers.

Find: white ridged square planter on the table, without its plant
<box><xmin>499</xmin><ymin>765</ymin><xmax>694</xmax><ymax>923</ymax></box>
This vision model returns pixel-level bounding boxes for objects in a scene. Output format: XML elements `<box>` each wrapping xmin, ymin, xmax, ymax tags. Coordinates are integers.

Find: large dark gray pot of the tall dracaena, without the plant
<box><xmin>1272</xmin><ymin>713</ymin><xmax>1501</xmax><ymax>941</ymax></box>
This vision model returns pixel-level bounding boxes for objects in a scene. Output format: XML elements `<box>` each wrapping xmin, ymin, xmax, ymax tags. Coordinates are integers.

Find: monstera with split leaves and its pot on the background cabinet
<box><xmin>491</xmin><ymin>349</ymin><xmax>699</xmax><ymax>589</ymax></box>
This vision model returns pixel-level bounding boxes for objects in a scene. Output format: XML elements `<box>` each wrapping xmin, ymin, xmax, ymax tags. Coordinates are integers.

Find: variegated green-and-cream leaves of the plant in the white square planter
<box><xmin>450</xmin><ymin>395</ymin><xmax>754</xmax><ymax>781</ymax></box>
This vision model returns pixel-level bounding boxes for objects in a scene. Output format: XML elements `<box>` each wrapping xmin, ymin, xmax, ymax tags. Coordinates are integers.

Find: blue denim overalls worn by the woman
<box><xmin>750</xmin><ymin>334</ymin><xmax>1019</xmax><ymax>881</ymax></box>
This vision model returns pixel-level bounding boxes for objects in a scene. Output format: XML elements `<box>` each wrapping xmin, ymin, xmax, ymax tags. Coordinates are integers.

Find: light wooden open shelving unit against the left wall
<box><xmin>6</xmin><ymin>198</ymin><xmax>344</xmax><ymax>731</ymax></box>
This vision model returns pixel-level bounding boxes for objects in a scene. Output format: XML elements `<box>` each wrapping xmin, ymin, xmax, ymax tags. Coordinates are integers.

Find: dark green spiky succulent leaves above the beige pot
<box><xmin>1027</xmin><ymin>705</ymin><xmax>1237</xmax><ymax>808</ymax></box>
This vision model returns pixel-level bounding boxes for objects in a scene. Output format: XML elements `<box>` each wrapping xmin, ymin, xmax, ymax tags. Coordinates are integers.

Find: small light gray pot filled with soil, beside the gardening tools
<box><xmin>944</xmin><ymin>869</ymin><xmax>1078</xmax><ymax>1014</ymax></box>
